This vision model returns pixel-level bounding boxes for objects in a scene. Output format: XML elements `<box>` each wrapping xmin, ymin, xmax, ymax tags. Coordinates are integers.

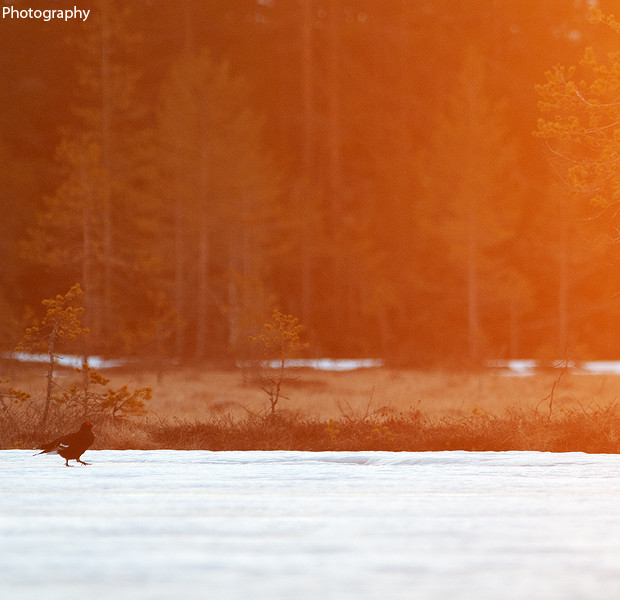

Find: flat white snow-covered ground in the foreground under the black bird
<box><xmin>0</xmin><ymin>450</ymin><xmax>620</xmax><ymax>600</ymax></box>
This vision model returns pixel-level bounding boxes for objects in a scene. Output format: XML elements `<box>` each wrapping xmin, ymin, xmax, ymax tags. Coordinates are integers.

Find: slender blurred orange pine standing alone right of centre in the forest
<box><xmin>429</xmin><ymin>46</ymin><xmax>518</xmax><ymax>361</ymax></box>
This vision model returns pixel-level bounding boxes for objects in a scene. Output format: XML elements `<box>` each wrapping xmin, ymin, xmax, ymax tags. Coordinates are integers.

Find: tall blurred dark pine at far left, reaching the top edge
<box><xmin>24</xmin><ymin>0</ymin><xmax>157</xmax><ymax>352</ymax></box>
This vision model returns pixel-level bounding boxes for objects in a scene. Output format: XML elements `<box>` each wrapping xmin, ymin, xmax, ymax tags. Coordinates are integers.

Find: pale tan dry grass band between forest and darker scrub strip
<box><xmin>0</xmin><ymin>365</ymin><xmax>620</xmax><ymax>421</ymax></box>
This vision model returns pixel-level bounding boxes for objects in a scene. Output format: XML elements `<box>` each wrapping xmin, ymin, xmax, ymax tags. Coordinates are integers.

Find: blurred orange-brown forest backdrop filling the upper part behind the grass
<box><xmin>0</xmin><ymin>0</ymin><xmax>620</xmax><ymax>364</ymax></box>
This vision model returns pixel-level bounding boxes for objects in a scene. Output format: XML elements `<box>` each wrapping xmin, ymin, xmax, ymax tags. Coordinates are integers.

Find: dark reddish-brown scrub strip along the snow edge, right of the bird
<box><xmin>140</xmin><ymin>408</ymin><xmax>620</xmax><ymax>453</ymax></box>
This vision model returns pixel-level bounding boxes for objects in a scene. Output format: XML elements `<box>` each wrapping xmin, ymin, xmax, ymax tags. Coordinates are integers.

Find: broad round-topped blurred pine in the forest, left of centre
<box><xmin>158</xmin><ymin>51</ymin><xmax>278</xmax><ymax>359</ymax></box>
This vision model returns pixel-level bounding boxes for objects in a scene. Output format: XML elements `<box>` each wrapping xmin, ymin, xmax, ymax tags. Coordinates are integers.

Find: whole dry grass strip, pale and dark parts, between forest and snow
<box><xmin>0</xmin><ymin>358</ymin><xmax>620</xmax><ymax>452</ymax></box>
